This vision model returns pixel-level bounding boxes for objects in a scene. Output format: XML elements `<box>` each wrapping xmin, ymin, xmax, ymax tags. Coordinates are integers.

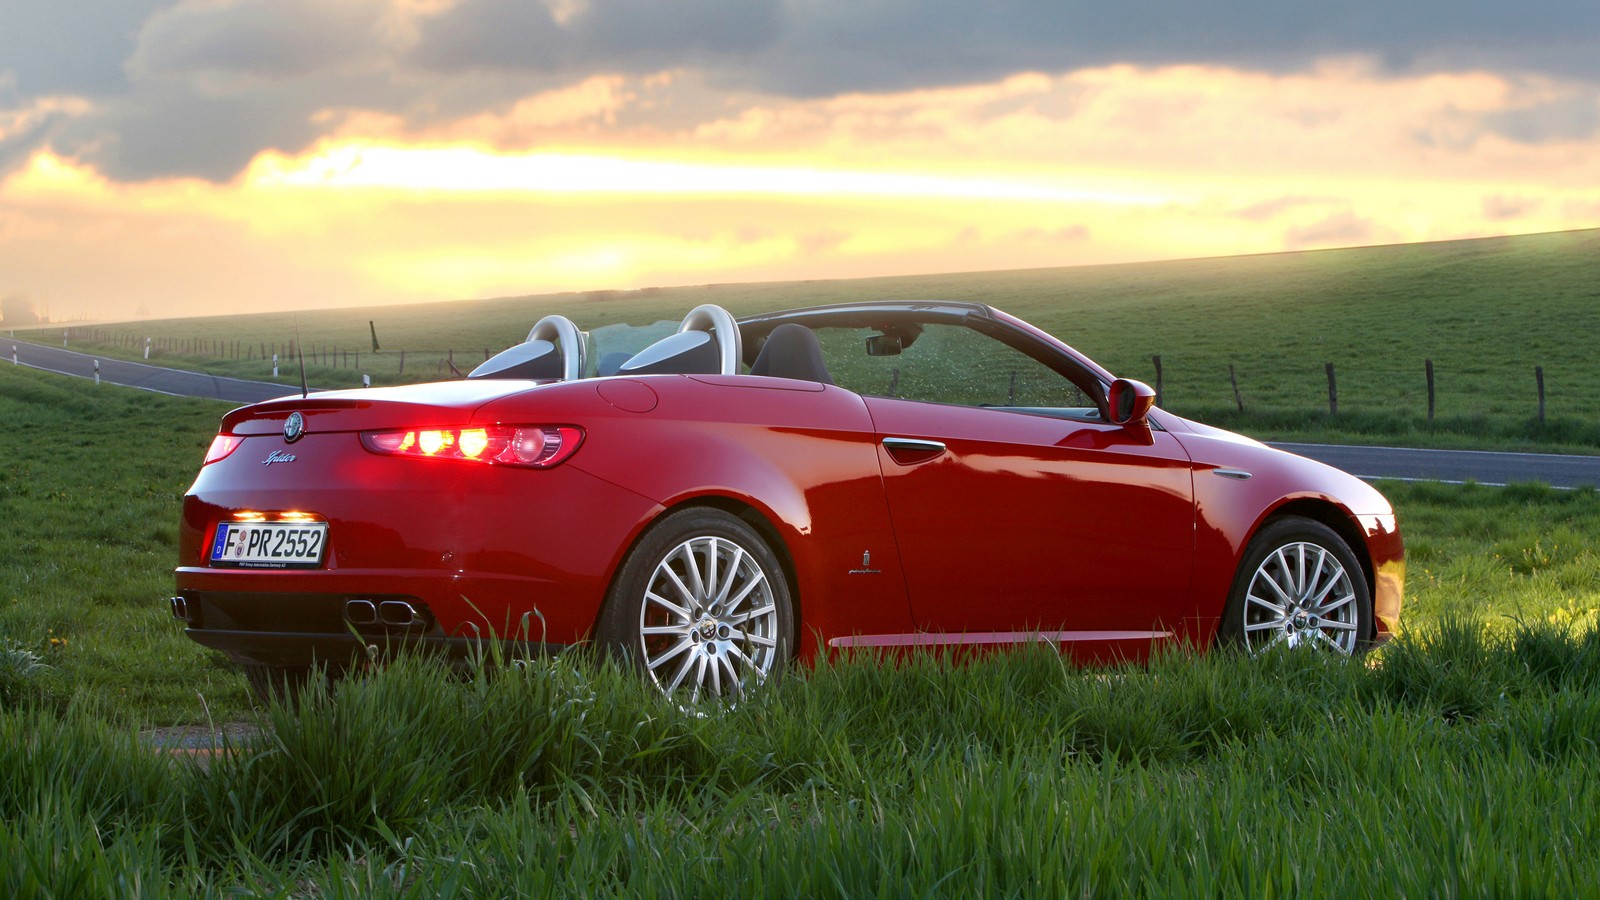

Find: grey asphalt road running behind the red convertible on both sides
<box><xmin>12</xmin><ymin>341</ymin><xmax>1600</xmax><ymax>488</ymax></box>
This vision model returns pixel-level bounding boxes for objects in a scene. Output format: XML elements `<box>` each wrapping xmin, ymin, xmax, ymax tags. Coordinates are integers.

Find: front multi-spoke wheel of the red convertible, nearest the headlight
<box><xmin>1218</xmin><ymin>517</ymin><xmax>1373</xmax><ymax>657</ymax></box>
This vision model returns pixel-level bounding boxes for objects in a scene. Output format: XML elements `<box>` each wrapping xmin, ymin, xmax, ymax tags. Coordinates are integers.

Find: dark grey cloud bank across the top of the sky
<box><xmin>0</xmin><ymin>0</ymin><xmax>1600</xmax><ymax>179</ymax></box>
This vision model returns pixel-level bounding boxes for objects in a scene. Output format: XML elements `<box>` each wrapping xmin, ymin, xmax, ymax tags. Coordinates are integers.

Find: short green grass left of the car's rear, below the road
<box><xmin>0</xmin><ymin>365</ymin><xmax>245</xmax><ymax>722</ymax></box>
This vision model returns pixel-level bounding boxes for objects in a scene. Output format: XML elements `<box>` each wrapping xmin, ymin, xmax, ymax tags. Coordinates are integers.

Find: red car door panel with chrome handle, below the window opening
<box><xmin>867</xmin><ymin>397</ymin><xmax>1194</xmax><ymax>642</ymax></box>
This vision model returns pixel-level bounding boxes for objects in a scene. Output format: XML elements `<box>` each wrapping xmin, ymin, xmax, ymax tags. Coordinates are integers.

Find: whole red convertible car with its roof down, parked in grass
<box><xmin>171</xmin><ymin>301</ymin><xmax>1405</xmax><ymax>703</ymax></box>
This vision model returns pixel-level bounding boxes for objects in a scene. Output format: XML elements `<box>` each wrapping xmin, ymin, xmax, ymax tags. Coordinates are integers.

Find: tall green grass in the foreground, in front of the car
<box><xmin>0</xmin><ymin>620</ymin><xmax>1600</xmax><ymax>897</ymax></box>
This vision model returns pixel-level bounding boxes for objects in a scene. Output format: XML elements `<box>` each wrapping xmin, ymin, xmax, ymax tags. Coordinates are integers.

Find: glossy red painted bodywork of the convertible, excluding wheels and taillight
<box><xmin>174</xmin><ymin>299</ymin><xmax>1403</xmax><ymax>665</ymax></box>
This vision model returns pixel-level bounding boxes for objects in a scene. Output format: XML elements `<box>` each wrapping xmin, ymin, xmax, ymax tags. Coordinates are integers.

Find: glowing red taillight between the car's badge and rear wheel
<box><xmin>362</xmin><ymin>424</ymin><xmax>584</xmax><ymax>469</ymax></box>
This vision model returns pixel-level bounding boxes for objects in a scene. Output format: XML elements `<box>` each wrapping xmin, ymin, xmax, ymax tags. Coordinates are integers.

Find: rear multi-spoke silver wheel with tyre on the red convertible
<box><xmin>597</xmin><ymin>509</ymin><xmax>794</xmax><ymax>705</ymax></box>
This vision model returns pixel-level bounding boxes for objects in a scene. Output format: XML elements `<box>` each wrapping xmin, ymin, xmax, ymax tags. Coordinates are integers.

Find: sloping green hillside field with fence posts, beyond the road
<box><xmin>19</xmin><ymin>229</ymin><xmax>1600</xmax><ymax>453</ymax></box>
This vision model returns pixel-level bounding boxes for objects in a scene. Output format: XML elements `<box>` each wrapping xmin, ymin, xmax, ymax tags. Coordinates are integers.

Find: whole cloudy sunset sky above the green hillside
<box><xmin>0</xmin><ymin>0</ymin><xmax>1600</xmax><ymax>320</ymax></box>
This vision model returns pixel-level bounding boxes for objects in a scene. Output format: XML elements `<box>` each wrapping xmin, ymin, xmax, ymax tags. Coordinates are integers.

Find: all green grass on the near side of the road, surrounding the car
<box><xmin>0</xmin><ymin>350</ymin><xmax>1600</xmax><ymax>897</ymax></box>
